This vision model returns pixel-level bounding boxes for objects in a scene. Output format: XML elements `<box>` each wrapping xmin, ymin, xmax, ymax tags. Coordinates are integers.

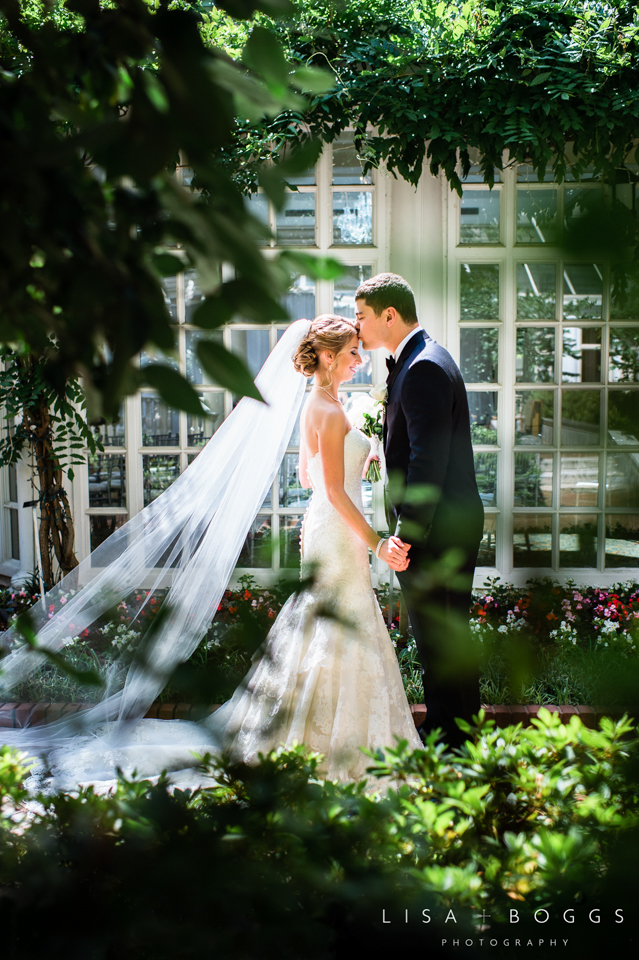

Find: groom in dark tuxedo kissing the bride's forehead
<box><xmin>355</xmin><ymin>273</ymin><xmax>484</xmax><ymax>746</ymax></box>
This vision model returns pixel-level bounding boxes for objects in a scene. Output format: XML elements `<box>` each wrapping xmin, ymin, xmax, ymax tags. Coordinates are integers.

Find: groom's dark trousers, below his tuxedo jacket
<box><xmin>397</xmin><ymin>542</ymin><xmax>480</xmax><ymax>746</ymax></box>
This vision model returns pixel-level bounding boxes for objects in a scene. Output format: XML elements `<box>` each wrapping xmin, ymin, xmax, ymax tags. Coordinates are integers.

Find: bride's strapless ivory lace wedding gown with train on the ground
<box><xmin>27</xmin><ymin>429</ymin><xmax>421</xmax><ymax>789</ymax></box>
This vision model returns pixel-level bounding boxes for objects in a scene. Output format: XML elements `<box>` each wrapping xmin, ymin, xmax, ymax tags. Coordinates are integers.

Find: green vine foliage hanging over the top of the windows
<box><xmin>211</xmin><ymin>0</ymin><xmax>639</xmax><ymax>190</ymax></box>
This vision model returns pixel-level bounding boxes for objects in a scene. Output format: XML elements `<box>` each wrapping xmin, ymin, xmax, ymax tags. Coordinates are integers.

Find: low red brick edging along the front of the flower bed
<box><xmin>0</xmin><ymin>702</ymin><xmax>632</xmax><ymax>728</ymax></box>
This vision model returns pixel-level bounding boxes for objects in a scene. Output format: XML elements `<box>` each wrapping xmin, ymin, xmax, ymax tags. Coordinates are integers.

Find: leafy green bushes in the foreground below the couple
<box><xmin>0</xmin><ymin>712</ymin><xmax>639</xmax><ymax>960</ymax></box>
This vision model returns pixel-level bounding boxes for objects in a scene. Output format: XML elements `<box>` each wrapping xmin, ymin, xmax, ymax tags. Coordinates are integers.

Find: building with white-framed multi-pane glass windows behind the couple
<box><xmin>0</xmin><ymin>133</ymin><xmax>639</xmax><ymax>586</ymax></box>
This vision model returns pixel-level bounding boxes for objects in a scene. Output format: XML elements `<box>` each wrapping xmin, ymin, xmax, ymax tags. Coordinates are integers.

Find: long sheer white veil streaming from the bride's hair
<box><xmin>0</xmin><ymin>320</ymin><xmax>311</xmax><ymax>748</ymax></box>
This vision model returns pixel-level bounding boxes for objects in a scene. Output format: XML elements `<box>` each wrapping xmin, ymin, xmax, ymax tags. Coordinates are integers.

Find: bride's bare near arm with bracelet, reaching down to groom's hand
<box><xmin>317</xmin><ymin>409</ymin><xmax>404</xmax><ymax>569</ymax></box>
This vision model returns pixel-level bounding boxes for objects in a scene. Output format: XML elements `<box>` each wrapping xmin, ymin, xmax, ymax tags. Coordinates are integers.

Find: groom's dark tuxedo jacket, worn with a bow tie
<box><xmin>384</xmin><ymin>330</ymin><xmax>484</xmax><ymax>556</ymax></box>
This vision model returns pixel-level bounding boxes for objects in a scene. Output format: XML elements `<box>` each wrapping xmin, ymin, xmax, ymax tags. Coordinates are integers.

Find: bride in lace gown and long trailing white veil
<box><xmin>2</xmin><ymin>315</ymin><xmax>421</xmax><ymax>789</ymax></box>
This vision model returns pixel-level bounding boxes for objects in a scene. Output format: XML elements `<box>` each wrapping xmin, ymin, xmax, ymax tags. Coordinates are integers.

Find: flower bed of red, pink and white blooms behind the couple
<box><xmin>0</xmin><ymin>575</ymin><xmax>639</xmax><ymax>706</ymax></box>
